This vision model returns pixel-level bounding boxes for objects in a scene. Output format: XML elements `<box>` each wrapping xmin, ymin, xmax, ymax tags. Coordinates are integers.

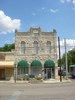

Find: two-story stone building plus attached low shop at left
<box><xmin>0</xmin><ymin>27</ymin><xmax>58</xmax><ymax>80</ymax></box>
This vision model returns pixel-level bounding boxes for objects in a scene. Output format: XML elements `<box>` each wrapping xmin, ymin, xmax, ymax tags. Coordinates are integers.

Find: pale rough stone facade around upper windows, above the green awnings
<box><xmin>15</xmin><ymin>28</ymin><xmax>58</xmax><ymax>77</ymax></box>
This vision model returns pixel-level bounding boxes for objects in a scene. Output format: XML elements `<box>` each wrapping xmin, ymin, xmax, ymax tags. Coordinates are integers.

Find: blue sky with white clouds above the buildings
<box><xmin>0</xmin><ymin>0</ymin><xmax>75</xmax><ymax>54</ymax></box>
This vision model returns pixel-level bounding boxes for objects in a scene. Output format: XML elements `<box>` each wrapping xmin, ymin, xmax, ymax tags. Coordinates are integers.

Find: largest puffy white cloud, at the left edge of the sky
<box><xmin>0</xmin><ymin>11</ymin><xmax>21</xmax><ymax>34</ymax></box>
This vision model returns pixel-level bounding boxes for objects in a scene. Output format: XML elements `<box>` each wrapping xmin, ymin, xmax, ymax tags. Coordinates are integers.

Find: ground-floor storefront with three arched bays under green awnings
<box><xmin>17</xmin><ymin>60</ymin><xmax>55</xmax><ymax>80</ymax></box>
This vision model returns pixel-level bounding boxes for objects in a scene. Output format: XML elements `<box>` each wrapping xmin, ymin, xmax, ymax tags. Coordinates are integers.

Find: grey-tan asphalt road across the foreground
<box><xmin>0</xmin><ymin>79</ymin><xmax>75</xmax><ymax>100</ymax></box>
